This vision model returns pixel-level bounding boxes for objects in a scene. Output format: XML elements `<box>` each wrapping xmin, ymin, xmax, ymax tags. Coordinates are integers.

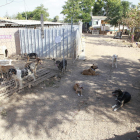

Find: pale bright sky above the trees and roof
<box><xmin>0</xmin><ymin>0</ymin><xmax>140</xmax><ymax>20</ymax></box>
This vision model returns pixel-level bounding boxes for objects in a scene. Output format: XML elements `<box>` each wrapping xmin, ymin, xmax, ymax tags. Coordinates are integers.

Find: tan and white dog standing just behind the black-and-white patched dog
<box><xmin>25</xmin><ymin>58</ymin><xmax>42</xmax><ymax>76</ymax></box>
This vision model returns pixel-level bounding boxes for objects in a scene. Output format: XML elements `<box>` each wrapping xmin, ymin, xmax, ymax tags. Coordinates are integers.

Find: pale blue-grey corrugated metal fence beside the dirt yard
<box><xmin>19</xmin><ymin>24</ymin><xmax>82</xmax><ymax>58</ymax></box>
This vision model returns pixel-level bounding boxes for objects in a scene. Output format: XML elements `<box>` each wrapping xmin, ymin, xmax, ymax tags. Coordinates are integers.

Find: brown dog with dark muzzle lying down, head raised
<box><xmin>82</xmin><ymin>64</ymin><xmax>99</xmax><ymax>76</ymax></box>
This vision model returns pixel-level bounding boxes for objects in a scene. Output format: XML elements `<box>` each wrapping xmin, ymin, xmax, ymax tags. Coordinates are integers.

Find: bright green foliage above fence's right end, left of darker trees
<box><xmin>61</xmin><ymin>0</ymin><xmax>95</xmax><ymax>22</ymax></box>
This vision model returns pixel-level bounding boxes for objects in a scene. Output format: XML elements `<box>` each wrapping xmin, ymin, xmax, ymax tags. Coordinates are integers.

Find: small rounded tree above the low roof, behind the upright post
<box><xmin>33</xmin><ymin>4</ymin><xmax>49</xmax><ymax>21</ymax></box>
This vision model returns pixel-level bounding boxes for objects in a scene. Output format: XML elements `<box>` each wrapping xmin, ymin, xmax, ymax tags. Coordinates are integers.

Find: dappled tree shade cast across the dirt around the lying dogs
<box><xmin>1</xmin><ymin>56</ymin><xmax>140</xmax><ymax>140</ymax></box>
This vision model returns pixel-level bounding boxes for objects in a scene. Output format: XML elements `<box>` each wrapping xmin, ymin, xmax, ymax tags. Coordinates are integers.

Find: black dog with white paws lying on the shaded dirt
<box><xmin>112</xmin><ymin>89</ymin><xmax>131</xmax><ymax>111</ymax></box>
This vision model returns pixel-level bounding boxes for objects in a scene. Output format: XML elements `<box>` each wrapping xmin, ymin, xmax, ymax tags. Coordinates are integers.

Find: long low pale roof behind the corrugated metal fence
<box><xmin>0</xmin><ymin>18</ymin><xmax>63</xmax><ymax>26</ymax></box>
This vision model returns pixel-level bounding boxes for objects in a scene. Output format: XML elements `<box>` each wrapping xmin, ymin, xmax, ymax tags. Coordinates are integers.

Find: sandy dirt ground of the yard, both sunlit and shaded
<box><xmin>0</xmin><ymin>34</ymin><xmax>140</xmax><ymax>140</ymax></box>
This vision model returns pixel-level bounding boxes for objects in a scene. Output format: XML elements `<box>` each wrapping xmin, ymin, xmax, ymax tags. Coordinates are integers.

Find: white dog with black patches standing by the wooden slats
<box><xmin>8</xmin><ymin>68</ymin><xmax>36</xmax><ymax>89</ymax></box>
